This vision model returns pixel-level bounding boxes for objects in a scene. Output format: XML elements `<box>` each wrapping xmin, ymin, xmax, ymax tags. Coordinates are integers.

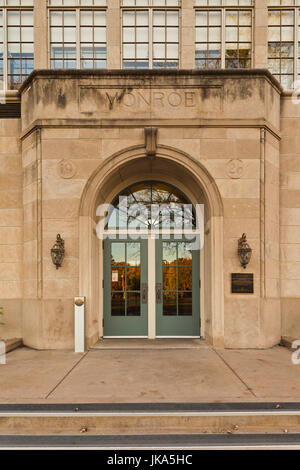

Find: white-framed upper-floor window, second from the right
<box><xmin>194</xmin><ymin>2</ymin><xmax>255</xmax><ymax>70</ymax></box>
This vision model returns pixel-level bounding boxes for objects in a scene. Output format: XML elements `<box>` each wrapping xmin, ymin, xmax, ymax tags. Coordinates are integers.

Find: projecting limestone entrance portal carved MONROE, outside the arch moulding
<box><xmin>21</xmin><ymin>71</ymin><xmax>280</xmax><ymax>349</ymax></box>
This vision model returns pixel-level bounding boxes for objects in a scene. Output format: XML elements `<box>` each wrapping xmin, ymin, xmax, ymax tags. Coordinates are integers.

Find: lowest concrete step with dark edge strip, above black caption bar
<box><xmin>0</xmin><ymin>434</ymin><xmax>300</xmax><ymax>450</ymax></box>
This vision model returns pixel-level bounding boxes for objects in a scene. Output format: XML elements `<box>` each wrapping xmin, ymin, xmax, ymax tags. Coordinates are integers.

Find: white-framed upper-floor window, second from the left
<box><xmin>47</xmin><ymin>0</ymin><xmax>108</xmax><ymax>70</ymax></box>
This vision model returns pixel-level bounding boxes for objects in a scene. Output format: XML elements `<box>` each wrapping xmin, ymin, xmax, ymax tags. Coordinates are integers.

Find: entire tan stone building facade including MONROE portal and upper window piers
<box><xmin>0</xmin><ymin>0</ymin><xmax>300</xmax><ymax>349</ymax></box>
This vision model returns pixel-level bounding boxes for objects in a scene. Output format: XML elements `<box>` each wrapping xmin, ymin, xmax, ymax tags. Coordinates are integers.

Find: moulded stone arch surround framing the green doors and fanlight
<box><xmin>78</xmin><ymin>145</ymin><xmax>224</xmax><ymax>347</ymax></box>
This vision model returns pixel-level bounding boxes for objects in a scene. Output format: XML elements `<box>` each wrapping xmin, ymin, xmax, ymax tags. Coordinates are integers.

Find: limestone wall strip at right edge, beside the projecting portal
<box><xmin>280</xmin><ymin>93</ymin><xmax>300</xmax><ymax>339</ymax></box>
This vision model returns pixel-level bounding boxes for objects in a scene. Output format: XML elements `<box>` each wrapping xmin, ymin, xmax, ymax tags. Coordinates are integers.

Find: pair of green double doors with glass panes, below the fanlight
<box><xmin>103</xmin><ymin>237</ymin><xmax>200</xmax><ymax>337</ymax></box>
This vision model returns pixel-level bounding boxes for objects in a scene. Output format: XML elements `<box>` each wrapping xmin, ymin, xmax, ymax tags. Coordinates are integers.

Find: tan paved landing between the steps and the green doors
<box><xmin>0</xmin><ymin>340</ymin><xmax>300</xmax><ymax>403</ymax></box>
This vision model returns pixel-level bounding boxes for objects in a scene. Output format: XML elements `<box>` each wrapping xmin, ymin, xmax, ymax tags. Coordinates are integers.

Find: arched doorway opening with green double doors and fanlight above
<box><xmin>102</xmin><ymin>180</ymin><xmax>200</xmax><ymax>337</ymax></box>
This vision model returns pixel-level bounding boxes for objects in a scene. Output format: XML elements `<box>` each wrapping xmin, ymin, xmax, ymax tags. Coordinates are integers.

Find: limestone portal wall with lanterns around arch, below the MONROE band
<box><xmin>34</xmin><ymin>126</ymin><xmax>280</xmax><ymax>348</ymax></box>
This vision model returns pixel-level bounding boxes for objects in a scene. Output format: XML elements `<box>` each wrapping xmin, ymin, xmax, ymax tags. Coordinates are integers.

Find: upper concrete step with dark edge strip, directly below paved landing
<box><xmin>0</xmin><ymin>403</ymin><xmax>300</xmax><ymax>435</ymax></box>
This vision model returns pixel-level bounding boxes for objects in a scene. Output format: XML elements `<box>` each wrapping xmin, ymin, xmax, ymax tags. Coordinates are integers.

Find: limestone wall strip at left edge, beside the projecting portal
<box><xmin>0</xmin><ymin>119</ymin><xmax>23</xmax><ymax>338</ymax></box>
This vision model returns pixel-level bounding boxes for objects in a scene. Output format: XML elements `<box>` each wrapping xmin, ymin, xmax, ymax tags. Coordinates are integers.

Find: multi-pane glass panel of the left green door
<box><xmin>111</xmin><ymin>242</ymin><xmax>141</xmax><ymax>316</ymax></box>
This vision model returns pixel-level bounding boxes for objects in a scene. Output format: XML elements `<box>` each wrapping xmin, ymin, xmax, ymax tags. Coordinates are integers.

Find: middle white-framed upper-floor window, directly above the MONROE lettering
<box><xmin>120</xmin><ymin>0</ymin><xmax>181</xmax><ymax>70</ymax></box>
